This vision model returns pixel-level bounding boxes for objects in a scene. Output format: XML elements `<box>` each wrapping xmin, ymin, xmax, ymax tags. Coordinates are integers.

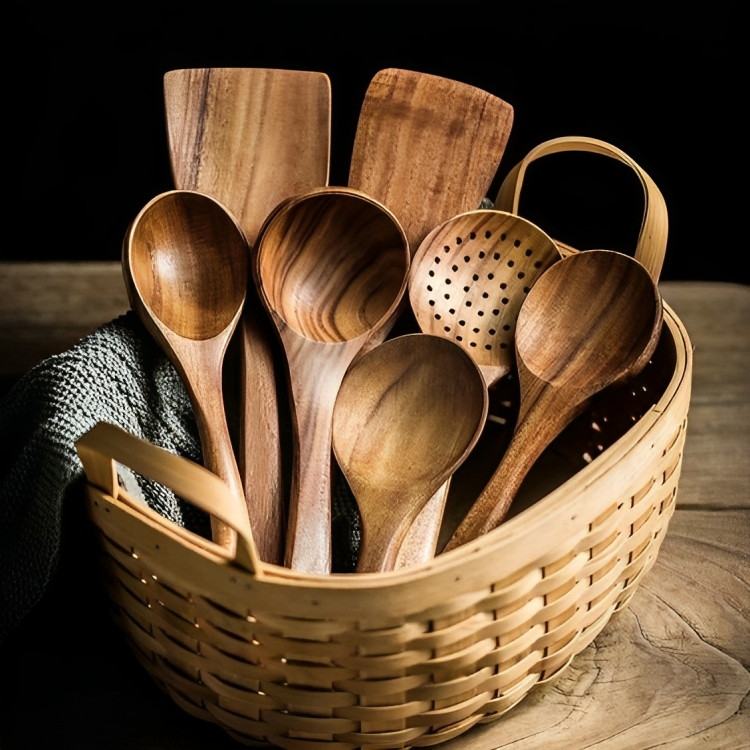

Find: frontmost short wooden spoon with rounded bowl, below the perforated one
<box><xmin>333</xmin><ymin>333</ymin><xmax>488</xmax><ymax>573</ymax></box>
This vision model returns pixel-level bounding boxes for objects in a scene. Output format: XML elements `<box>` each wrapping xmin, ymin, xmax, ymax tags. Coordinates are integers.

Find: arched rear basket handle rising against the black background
<box><xmin>495</xmin><ymin>136</ymin><xmax>669</xmax><ymax>282</ymax></box>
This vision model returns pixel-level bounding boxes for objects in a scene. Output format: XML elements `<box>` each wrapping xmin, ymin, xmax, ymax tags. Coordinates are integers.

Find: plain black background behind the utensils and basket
<box><xmin>11</xmin><ymin>0</ymin><xmax>750</xmax><ymax>283</ymax></box>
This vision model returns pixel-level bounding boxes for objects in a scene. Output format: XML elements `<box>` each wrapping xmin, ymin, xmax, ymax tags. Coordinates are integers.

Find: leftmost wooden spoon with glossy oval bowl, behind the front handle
<box><xmin>123</xmin><ymin>190</ymin><xmax>257</xmax><ymax>569</ymax></box>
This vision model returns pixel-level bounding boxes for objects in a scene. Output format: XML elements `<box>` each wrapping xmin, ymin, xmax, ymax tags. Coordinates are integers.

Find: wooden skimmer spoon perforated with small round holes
<box><xmin>403</xmin><ymin>210</ymin><xmax>560</xmax><ymax>566</ymax></box>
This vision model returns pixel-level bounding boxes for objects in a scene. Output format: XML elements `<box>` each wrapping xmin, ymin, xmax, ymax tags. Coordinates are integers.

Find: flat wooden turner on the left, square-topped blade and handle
<box><xmin>164</xmin><ymin>68</ymin><xmax>331</xmax><ymax>564</ymax></box>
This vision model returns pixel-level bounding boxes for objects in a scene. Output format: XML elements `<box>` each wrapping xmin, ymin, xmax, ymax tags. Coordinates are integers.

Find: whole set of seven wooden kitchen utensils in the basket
<box><xmin>123</xmin><ymin>68</ymin><xmax>662</xmax><ymax>574</ymax></box>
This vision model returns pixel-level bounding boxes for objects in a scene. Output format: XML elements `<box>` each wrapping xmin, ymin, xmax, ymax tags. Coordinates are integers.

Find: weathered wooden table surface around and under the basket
<box><xmin>0</xmin><ymin>263</ymin><xmax>750</xmax><ymax>750</ymax></box>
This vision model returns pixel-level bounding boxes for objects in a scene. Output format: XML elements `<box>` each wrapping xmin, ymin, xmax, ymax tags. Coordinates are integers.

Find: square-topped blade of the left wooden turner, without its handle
<box><xmin>164</xmin><ymin>68</ymin><xmax>331</xmax><ymax>245</ymax></box>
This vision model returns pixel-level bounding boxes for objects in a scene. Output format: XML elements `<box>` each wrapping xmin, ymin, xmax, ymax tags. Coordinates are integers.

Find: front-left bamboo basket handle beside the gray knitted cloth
<box><xmin>75</xmin><ymin>422</ymin><xmax>261</xmax><ymax>576</ymax></box>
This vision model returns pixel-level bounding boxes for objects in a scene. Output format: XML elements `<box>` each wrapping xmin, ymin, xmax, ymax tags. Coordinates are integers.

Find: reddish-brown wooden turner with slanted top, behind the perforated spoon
<box><xmin>349</xmin><ymin>68</ymin><xmax>513</xmax><ymax>356</ymax></box>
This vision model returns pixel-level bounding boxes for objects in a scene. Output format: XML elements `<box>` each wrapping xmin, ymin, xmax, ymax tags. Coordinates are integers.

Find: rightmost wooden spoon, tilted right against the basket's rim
<box><xmin>445</xmin><ymin>250</ymin><xmax>662</xmax><ymax>551</ymax></box>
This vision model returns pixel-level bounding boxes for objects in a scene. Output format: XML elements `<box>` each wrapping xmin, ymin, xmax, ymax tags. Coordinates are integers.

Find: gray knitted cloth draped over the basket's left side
<box><xmin>0</xmin><ymin>311</ymin><xmax>359</xmax><ymax>640</ymax></box>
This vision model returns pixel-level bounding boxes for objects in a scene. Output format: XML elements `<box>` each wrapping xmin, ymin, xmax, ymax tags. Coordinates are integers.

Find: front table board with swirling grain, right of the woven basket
<box><xmin>443</xmin><ymin>508</ymin><xmax>750</xmax><ymax>750</ymax></box>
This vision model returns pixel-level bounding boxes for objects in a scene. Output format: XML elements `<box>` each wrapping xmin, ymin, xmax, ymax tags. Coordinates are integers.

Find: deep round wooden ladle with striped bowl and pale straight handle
<box><xmin>254</xmin><ymin>188</ymin><xmax>409</xmax><ymax>573</ymax></box>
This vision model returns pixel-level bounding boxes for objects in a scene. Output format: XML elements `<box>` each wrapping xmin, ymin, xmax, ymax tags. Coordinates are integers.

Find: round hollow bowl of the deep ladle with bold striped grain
<box><xmin>258</xmin><ymin>188</ymin><xmax>408</xmax><ymax>344</ymax></box>
